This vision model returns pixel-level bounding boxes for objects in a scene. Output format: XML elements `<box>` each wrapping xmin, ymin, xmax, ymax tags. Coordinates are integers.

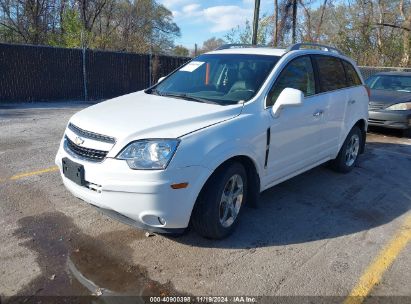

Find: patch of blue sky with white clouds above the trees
<box><xmin>158</xmin><ymin>0</ymin><xmax>274</xmax><ymax>49</ymax></box>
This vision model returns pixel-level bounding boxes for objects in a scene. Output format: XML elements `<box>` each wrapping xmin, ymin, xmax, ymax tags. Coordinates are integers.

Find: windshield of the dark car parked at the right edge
<box><xmin>366</xmin><ymin>75</ymin><xmax>411</xmax><ymax>92</ymax></box>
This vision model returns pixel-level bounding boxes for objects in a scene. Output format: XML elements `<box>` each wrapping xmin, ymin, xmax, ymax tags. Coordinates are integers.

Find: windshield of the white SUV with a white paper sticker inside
<box><xmin>150</xmin><ymin>54</ymin><xmax>280</xmax><ymax>105</ymax></box>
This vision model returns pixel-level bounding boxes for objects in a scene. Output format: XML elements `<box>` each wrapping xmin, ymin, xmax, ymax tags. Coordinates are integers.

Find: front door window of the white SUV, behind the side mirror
<box><xmin>266</xmin><ymin>56</ymin><xmax>315</xmax><ymax>107</ymax></box>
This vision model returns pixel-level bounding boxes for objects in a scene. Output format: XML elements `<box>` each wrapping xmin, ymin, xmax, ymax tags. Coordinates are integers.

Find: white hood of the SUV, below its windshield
<box><xmin>70</xmin><ymin>91</ymin><xmax>243</xmax><ymax>140</ymax></box>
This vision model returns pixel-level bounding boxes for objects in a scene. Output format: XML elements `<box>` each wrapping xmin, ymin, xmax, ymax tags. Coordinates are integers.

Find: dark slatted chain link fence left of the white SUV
<box><xmin>0</xmin><ymin>43</ymin><xmax>191</xmax><ymax>103</ymax></box>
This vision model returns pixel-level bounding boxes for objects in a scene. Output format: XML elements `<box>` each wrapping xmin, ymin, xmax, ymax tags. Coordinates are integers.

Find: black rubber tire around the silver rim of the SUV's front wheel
<box><xmin>191</xmin><ymin>162</ymin><xmax>247</xmax><ymax>239</ymax></box>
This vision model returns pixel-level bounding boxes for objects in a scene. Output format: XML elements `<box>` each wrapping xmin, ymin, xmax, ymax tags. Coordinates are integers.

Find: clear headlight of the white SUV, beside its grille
<box><xmin>117</xmin><ymin>139</ymin><xmax>180</xmax><ymax>170</ymax></box>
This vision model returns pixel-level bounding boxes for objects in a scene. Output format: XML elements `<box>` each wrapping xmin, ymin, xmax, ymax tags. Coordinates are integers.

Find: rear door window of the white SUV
<box><xmin>315</xmin><ymin>56</ymin><xmax>347</xmax><ymax>92</ymax></box>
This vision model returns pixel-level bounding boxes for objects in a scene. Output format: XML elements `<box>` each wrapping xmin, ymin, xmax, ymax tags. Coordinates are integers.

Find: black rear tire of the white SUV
<box><xmin>330</xmin><ymin>126</ymin><xmax>363</xmax><ymax>173</ymax></box>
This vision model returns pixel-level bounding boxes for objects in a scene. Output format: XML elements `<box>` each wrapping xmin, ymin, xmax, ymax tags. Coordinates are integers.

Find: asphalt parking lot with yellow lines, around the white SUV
<box><xmin>0</xmin><ymin>103</ymin><xmax>411</xmax><ymax>303</ymax></box>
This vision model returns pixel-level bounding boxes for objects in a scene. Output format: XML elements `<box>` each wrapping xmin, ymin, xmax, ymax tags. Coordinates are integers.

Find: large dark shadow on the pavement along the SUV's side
<box><xmin>169</xmin><ymin>142</ymin><xmax>411</xmax><ymax>249</ymax></box>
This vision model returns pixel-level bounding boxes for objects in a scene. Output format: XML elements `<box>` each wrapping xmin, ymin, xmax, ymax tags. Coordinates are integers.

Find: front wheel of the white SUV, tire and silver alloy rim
<box><xmin>192</xmin><ymin>163</ymin><xmax>247</xmax><ymax>239</ymax></box>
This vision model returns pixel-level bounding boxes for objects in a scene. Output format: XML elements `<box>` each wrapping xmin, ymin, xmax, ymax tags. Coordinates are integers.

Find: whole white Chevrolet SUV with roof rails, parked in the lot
<box><xmin>56</xmin><ymin>44</ymin><xmax>369</xmax><ymax>238</ymax></box>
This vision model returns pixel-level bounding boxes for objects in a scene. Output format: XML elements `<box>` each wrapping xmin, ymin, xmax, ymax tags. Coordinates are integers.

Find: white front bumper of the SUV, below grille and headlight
<box><xmin>55</xmin><ymin>147</ymin><xmax>211</xmax><ymax>233</ymax></box>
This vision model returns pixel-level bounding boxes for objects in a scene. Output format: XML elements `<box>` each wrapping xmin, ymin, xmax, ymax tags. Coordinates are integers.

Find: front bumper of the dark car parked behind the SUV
<box><xmin>368</xmin><ymin>111</ymin><xmax>411</xmax><ymax>130</ymax></box>
